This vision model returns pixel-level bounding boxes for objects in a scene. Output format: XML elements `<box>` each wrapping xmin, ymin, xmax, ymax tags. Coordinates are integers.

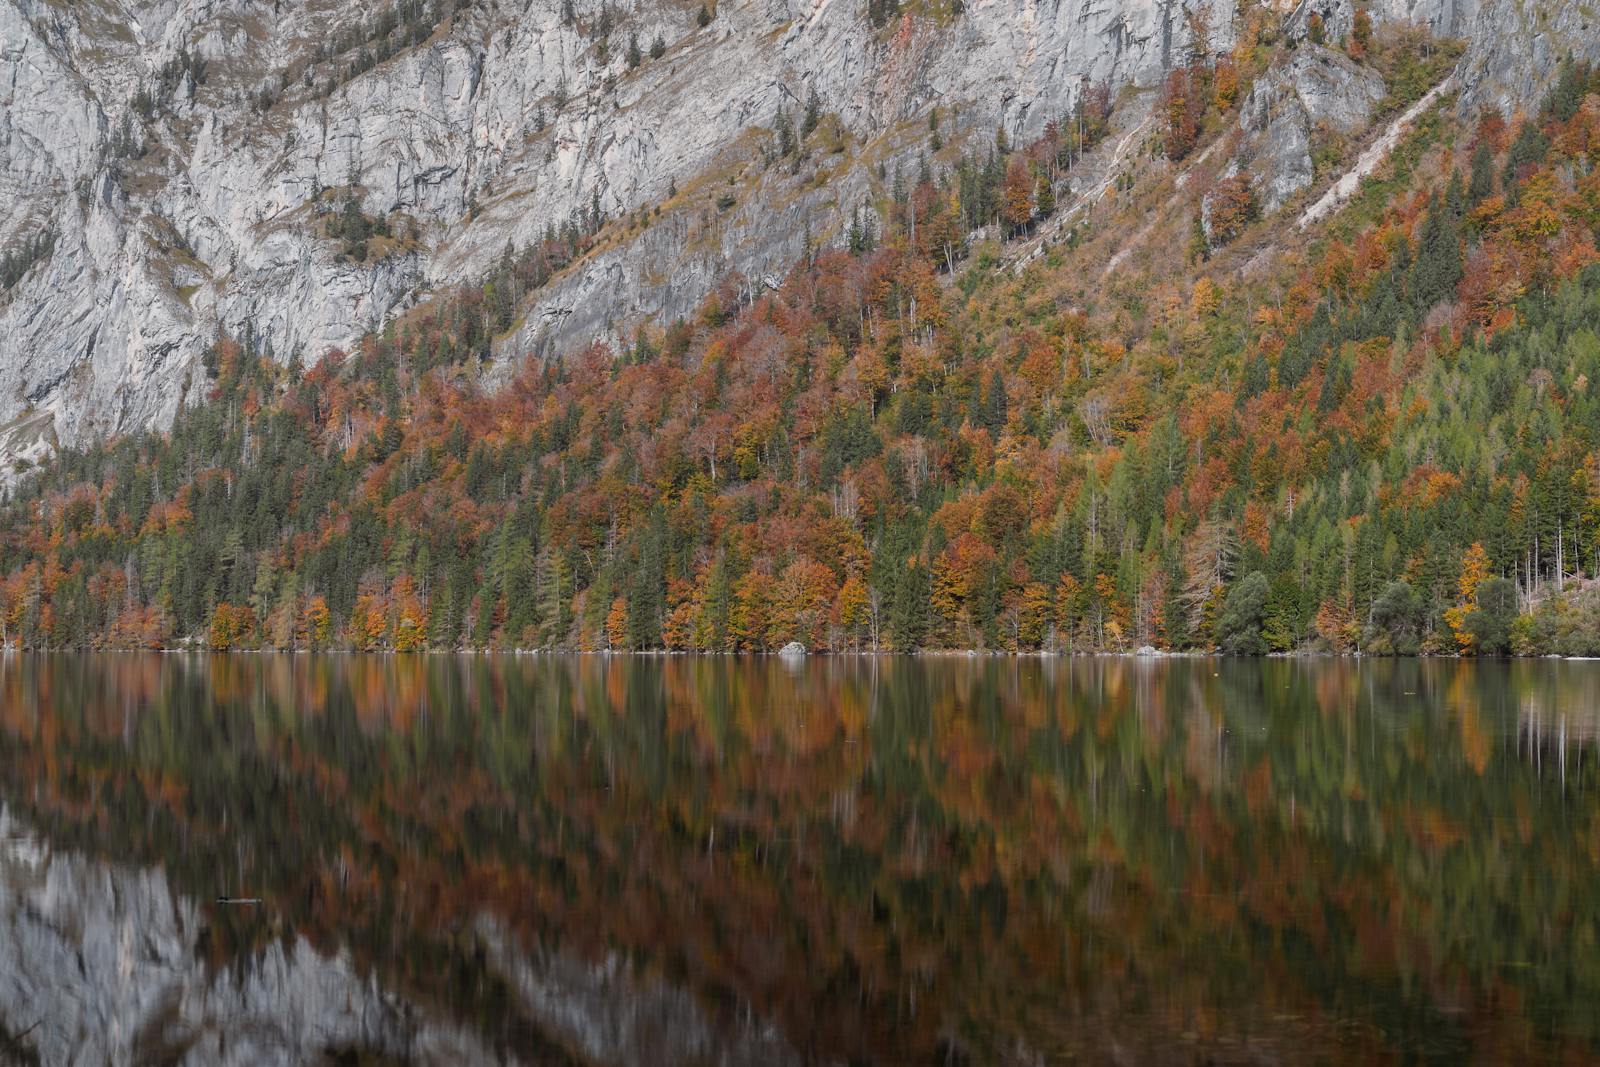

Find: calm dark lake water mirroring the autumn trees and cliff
<box><xmin>0</xmin><ymin>654</ymin><xmax>1600</xmax><ymax>1064</ymax></box>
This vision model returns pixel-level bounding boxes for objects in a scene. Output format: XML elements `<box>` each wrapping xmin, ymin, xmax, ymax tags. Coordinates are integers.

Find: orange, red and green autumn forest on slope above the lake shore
<box><xmin>0</xmin><ymin>45</ymin><xmax>1600</xmax><ymax>654</ymax></box>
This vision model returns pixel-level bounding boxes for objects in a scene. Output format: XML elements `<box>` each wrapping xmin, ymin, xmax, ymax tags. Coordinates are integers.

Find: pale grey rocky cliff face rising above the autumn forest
<box><xmin>0</xmin><ymin>0</ymin><xmax>1597</xmax><ymax>456</ymax></box>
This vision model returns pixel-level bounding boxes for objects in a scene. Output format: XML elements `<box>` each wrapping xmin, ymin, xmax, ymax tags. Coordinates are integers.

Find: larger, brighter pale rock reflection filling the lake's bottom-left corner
<box><xmin>0</xmin><ymin>811</ymin><xmax>498</xmax><ymax>1064</ymax></box>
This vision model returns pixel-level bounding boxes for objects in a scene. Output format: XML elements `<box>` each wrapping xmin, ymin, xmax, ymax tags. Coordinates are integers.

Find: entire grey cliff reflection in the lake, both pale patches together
<box><xmin>0</xmin><ymin>808</ymin><xmax>797</xmax><ymax>1067</ymax></box>
